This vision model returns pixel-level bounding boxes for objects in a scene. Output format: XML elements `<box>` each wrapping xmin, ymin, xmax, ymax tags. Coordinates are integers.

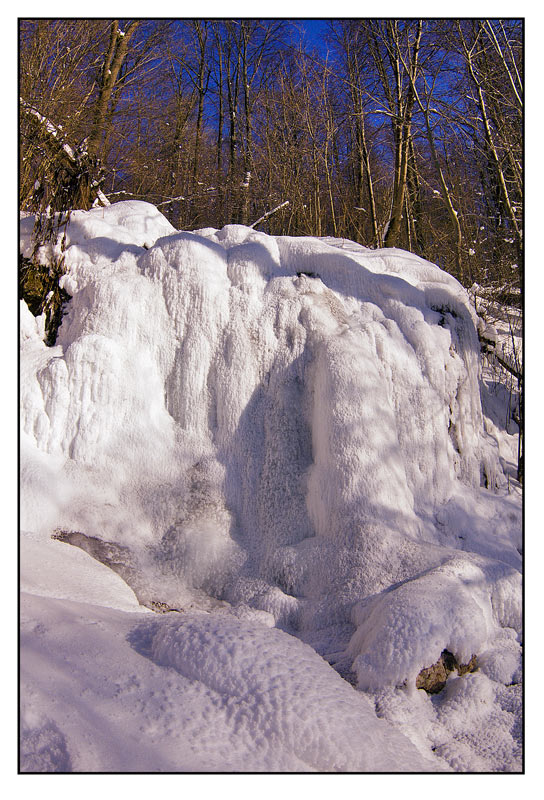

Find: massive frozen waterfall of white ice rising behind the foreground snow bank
<box><xmin>21</xmin><ymin>201</ymin><xmax>521</xmax><ymax>769</ymax></box>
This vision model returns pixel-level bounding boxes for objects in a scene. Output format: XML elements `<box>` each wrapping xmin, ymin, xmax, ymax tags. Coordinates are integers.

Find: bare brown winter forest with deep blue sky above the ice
<box><xmin>19</xmin><ymin>19</ymin><xmax>524</xmax><ymax>294</ymax></box>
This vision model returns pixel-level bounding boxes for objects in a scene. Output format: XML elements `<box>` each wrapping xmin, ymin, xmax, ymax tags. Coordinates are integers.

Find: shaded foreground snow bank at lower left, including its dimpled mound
<box><xmin>21</xmin><ymin>596</ymin><xmax>435</xmax><ymax>772</ymax></box>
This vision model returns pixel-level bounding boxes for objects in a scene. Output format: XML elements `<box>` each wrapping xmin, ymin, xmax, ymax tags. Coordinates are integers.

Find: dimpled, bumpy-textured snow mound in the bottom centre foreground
<box><xmin>151</xmin><ymin>614</ymin><xmax>429</xmax><ymax>772</ymax></box>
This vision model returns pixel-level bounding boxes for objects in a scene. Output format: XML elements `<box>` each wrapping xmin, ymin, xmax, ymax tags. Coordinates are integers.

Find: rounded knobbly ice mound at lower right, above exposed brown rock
<box><xmin>348</xmin><ymin>558</ymin><xmax>521</xmax><ymax>691</ymax></box>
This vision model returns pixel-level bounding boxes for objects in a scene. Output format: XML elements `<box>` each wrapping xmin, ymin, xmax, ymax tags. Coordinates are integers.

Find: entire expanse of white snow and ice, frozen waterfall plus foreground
<box><xmin>21</xmin><ymin>201</ymin><xmax>522</xmax><ymax>772</ymax></box>
